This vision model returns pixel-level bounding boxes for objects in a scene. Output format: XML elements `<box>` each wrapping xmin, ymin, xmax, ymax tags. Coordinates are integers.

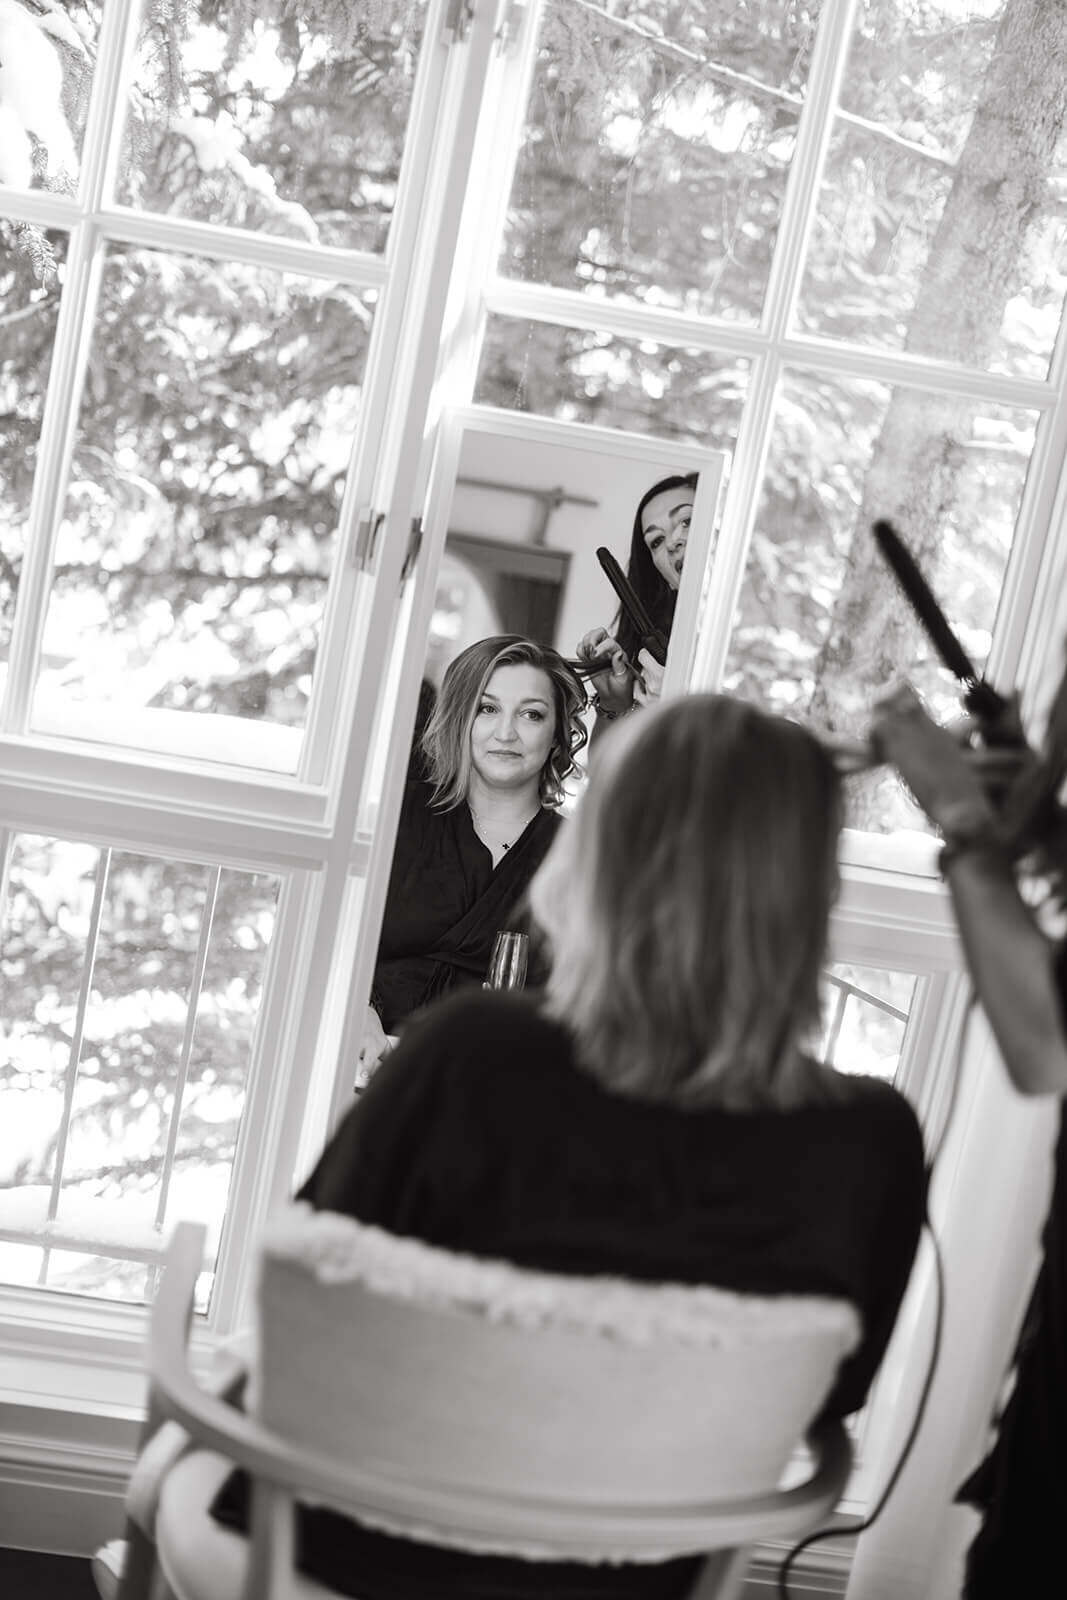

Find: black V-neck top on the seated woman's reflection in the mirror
<box><xmin>371</xmin><ymin>781</ymin><xmax>561</xmax><ymax>1034</ymax></box>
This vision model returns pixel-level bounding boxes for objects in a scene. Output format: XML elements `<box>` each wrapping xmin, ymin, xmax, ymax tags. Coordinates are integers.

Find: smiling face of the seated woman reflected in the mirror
<box><xmin>470</xmin><ymin>662</ymin><xmax>555</xmax><ymax>789</ymax></box>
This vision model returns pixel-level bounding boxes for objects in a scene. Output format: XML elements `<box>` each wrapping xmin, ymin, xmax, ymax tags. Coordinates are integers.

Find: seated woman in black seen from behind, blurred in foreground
<box><xmin>255</xmin><ymin>696</ymin><xmax>926</xmax><ymax>1600</ymax></box>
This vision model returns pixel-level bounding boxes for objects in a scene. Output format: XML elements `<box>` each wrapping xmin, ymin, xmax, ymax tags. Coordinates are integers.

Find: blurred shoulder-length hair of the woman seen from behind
<box><xmin>530</xmin><ymin>694</ymin><xmax>841</xmax><ymax>1109</ymax></box>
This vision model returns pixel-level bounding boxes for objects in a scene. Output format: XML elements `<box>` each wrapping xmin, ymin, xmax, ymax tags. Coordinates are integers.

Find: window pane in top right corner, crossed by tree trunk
<box><xmin>800</xmin><ymin>0</ymin><xmax>1067</xmax><ymax>378</ymax></box>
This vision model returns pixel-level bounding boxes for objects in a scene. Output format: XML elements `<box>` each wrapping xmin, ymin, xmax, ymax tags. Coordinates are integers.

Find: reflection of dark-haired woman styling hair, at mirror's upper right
<box><xmin>577</xmin><ymin>472</ymin><xmax>697</xmax><ymax>728</ymax></box>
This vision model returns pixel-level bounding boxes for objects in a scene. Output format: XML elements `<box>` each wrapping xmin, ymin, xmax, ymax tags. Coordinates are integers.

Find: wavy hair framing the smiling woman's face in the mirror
<box><xmin>422</xmin><ymin>634</ymin><xmax>589</xmax><ymax>811</ymax></box>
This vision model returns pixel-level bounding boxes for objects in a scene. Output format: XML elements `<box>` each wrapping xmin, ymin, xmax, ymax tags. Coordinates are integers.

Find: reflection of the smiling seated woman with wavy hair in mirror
<box><xmin>360</xmin><ymin>634</ymin><xmax>587</xmax><ymax>1074</ymax></box>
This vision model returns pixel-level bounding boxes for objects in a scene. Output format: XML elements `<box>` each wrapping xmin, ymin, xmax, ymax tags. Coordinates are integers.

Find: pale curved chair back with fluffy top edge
<box><xmin>250</xmin><ymin>1205</ymin><xmax>859</xmax><ymax>1558</ymax></box>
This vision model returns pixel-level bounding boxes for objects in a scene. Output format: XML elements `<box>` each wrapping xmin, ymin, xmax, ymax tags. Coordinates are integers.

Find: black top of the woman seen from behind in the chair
<box><xmin>207</xmin><ymin>990</ymin><xmax>926</xmax><ymax>1600</ymax></box>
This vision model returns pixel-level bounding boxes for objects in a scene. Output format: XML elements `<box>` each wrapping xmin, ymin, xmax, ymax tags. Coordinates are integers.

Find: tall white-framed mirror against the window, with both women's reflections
<box><xmin>358</xmin><ymin>408</ymin><xmax>723</xmax><ymax>1082</ymax></box>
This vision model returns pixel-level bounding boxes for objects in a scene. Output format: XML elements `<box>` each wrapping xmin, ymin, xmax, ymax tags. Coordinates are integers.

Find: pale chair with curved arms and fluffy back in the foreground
<box><xmin>110</xmin><ymin>1206</ymin><xmax>857</xmax><ymax>1600</ymax></box>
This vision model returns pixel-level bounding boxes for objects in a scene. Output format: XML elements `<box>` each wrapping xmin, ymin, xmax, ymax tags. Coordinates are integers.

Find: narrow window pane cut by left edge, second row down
<box><xmin>0</xmin><ymin>219</ymin><xmax>67</xmax><ymax>690</ymax></box>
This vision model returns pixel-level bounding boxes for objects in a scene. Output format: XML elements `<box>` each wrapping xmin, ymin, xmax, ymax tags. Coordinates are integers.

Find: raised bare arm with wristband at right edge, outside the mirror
<box><xmin>872</xmin><ymin>688</ymin><xmax>1067</xmax><ymax>1094</ymax></box>
